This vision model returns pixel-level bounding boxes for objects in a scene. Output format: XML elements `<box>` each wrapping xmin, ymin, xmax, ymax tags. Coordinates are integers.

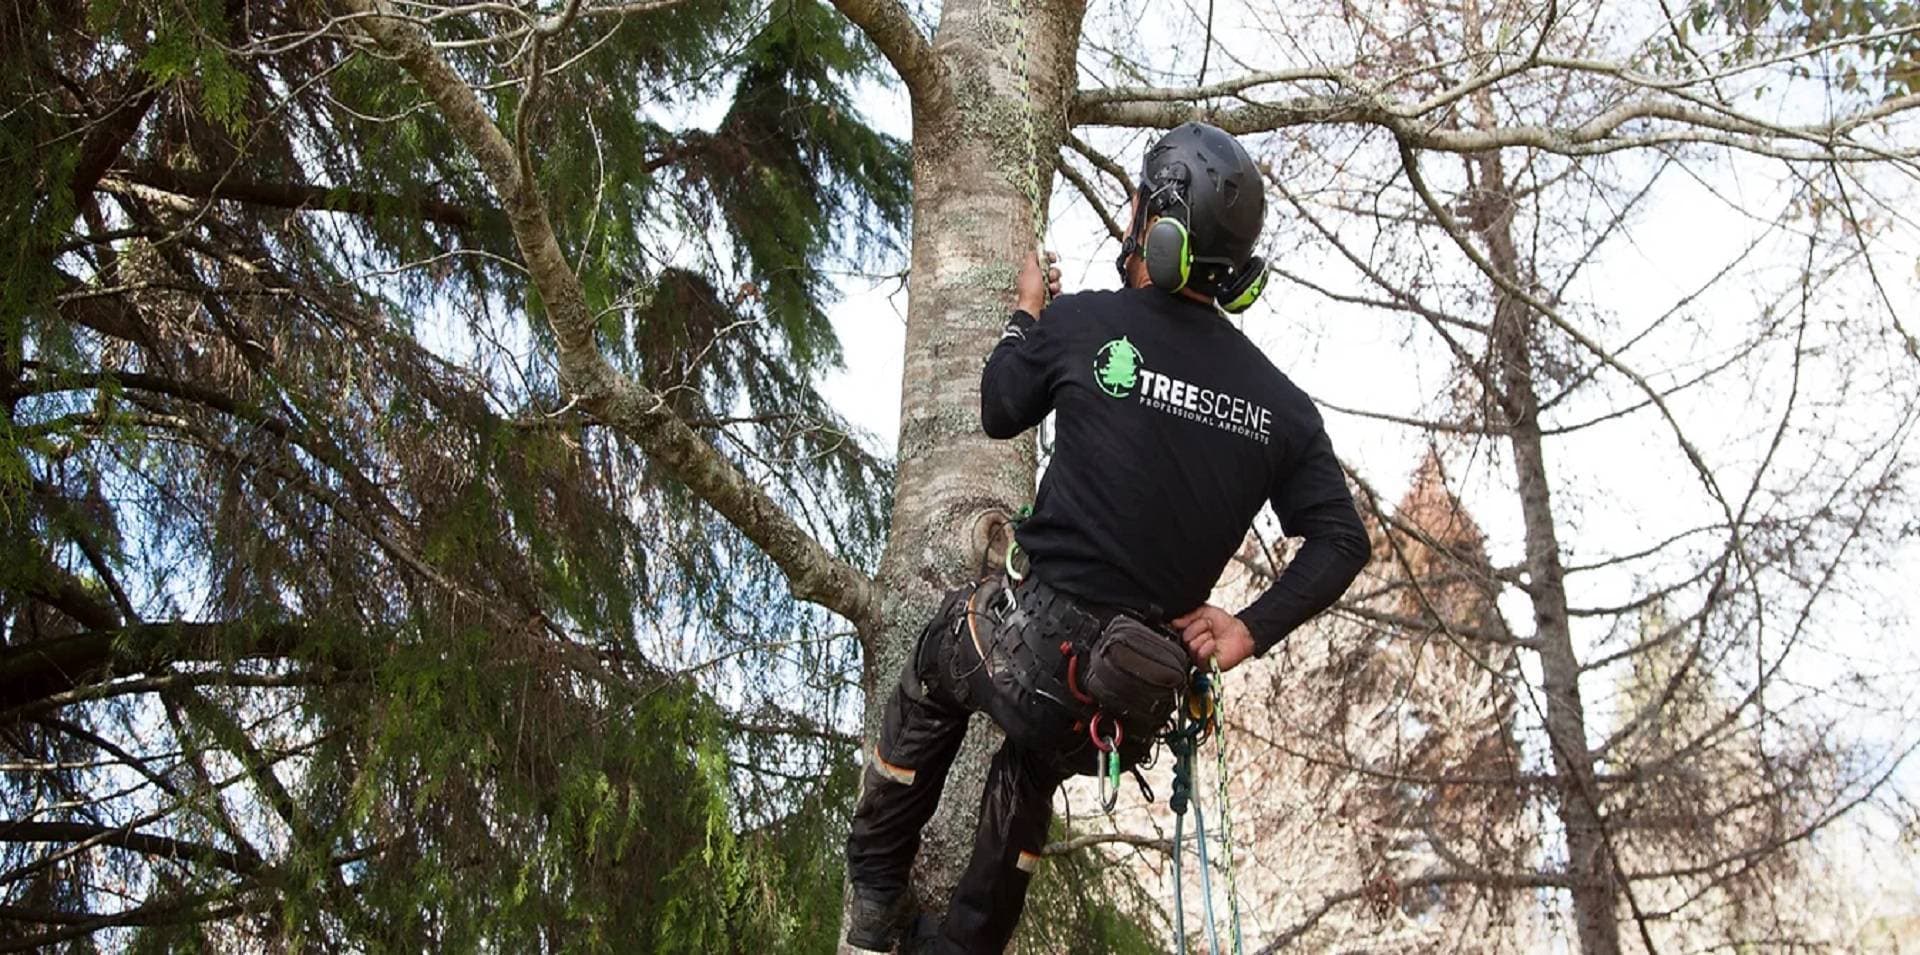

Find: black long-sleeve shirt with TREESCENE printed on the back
<box><xmin>979</xmin><ymin>288</ymin><xmax>1369</xmax><ymax>653</ymax></box>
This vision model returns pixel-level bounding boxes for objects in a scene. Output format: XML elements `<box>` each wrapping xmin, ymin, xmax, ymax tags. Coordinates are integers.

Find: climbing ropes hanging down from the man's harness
<box><xmin>1162</xmin><ymin>661</ymin><xmax>1246</xmax><ymax>955</ymax></box>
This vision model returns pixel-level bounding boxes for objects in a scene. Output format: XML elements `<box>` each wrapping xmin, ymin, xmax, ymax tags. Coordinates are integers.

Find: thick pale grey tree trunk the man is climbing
<box><xmin>862</xmin><ymin>0</ymin><xmax>1085</xmax><ymax>937</ymax></box>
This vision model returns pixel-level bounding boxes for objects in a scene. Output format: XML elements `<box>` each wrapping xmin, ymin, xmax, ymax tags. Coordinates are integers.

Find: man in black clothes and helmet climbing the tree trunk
<box><xmin>847</xmin><ymin>123</ymin><xmax>1369</xmax><ymax>953</ymax></box>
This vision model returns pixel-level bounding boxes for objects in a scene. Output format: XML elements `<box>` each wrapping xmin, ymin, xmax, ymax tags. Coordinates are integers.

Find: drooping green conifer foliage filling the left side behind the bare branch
<box><xmin>0</xmin><ymin>0</ymin><xmax>908</xmax><ymax>951</ymax></box>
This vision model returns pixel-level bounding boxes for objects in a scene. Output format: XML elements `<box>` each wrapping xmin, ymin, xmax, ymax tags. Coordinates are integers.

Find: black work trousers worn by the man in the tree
<box><xmin>847</xmin><ymin>582</ymin><xmax>1098</xmax><ymax>955</ymax></box>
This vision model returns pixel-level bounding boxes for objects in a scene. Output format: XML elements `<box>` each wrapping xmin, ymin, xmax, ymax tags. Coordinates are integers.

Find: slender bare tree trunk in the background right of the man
<box><xmin>1473</xmin><ymin>154</ymin><xmax>1620</xmax><ymax>955</ymax></box>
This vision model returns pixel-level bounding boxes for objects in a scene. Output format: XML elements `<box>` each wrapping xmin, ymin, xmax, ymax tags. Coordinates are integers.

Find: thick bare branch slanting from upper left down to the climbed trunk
<box><xmin>338</xmin><ymin>0</ymin><xmax>879</xmax><ymax>632</ymax></box>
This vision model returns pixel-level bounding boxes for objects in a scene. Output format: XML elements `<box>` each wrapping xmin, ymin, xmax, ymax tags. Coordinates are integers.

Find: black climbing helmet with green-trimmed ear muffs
<box><xmin>1119</xmin><ymin>123</ymin><xmax>1267</xmax><ymax>311</ymax></box>
